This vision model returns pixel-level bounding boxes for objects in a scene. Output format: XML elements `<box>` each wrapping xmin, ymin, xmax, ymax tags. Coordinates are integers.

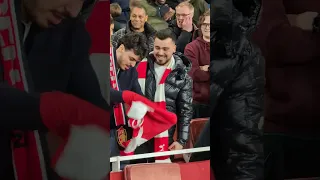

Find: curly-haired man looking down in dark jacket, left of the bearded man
<box><xmin>110</xmin><ymin>32</ymin><xmax>148</xmax><ymax>167</ymax></box>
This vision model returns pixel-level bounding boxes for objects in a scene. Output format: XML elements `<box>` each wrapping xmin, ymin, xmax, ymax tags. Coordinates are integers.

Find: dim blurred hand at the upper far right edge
<box><xmin>287</xmin><ymin>12</ymin><xmax>318</xmax><ymax>31</ymax></box>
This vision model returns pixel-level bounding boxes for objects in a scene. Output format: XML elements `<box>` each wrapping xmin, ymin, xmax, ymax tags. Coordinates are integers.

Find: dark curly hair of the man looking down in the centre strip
<box><xmin>117</xmin><ymin>32</ymin><xmax>149</xmax><ymax>59</ymax></box>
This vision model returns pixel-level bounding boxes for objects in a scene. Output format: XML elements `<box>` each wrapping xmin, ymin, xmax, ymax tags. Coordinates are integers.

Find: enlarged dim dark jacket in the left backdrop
<box><xmin>0</xmin><ymin>0</ymin><xmax>109</xmax><ymax>180</ymax></box>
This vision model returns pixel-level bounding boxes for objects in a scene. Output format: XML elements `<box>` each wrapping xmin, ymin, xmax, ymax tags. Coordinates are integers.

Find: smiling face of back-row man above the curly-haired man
<box><xmin>130</xmin><ymin>8</ymin><xmax>148</xmax><ymax>31</ymax></box>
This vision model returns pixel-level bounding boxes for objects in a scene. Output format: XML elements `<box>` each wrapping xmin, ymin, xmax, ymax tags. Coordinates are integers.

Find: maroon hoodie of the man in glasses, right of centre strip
<box><xmin>184</xmin><ymin>37</ymin><xmax>210</xmax><ymax>104</ymax></box>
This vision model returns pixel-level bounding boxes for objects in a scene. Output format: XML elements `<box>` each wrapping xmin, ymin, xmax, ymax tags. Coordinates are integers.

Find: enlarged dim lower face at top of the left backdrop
<box><xmin>22</xmin><ymin>0</ymin><xmax>84</xmax><ymax>28</ymax></box>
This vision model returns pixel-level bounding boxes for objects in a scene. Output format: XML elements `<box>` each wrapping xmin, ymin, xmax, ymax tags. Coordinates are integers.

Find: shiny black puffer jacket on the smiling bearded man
<box><xmin>141</xmin><ymin>53</ymin><xmax>193</xmax><ymax>145</ymax></box>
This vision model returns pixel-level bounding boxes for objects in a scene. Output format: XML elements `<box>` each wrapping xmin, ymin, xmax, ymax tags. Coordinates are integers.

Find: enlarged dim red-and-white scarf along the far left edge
<box><xmin>0</xmin><ymin>0</ymin><xmax>48</xmax><ymax>180</ymax></box>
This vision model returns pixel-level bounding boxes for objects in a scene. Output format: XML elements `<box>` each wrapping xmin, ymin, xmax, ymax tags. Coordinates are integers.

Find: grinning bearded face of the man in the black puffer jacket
<box><xmin>153</xmin><ymin>38</ymin><xmax>176</xmax><ymax>66</ymax></box>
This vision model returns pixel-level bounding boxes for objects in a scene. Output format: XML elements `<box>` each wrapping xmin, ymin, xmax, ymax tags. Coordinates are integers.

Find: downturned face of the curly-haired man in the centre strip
<box><xmin>117</xmin><ymin>44</ymin><xmax>141</xmax><ymax>70</ymax></box>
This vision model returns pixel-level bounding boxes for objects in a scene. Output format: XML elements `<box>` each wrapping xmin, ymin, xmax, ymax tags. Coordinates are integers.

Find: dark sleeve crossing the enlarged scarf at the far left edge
<box><xmin>0</xmin><ymin>83</ymin><xmax>46</xmax><ymax>131</ymax></box>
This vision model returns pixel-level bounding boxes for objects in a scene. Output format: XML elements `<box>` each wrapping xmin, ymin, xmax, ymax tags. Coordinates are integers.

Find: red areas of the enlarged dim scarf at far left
<box><xmin>0</xmin><ymin>0</ymin><xmax>42</xmax><ymax>180</ymax></box>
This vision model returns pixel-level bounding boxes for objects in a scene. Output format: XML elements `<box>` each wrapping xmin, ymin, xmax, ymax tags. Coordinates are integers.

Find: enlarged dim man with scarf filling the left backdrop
<box><xmin>0</xmin><ymin>0</ymin><xmax>110</xmax><ymax>180</ymax></box>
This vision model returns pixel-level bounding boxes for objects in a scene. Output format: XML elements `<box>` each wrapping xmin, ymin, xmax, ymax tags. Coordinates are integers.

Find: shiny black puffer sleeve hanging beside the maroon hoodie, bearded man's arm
<box><xmin>176</xmin><ymin>75</ymin><xmax>193</xmax><ymax>146</ymax></box>
